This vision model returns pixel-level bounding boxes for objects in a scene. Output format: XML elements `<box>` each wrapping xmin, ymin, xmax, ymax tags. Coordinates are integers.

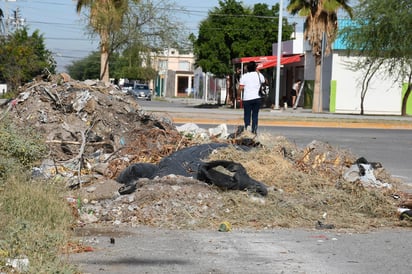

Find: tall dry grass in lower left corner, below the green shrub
<box><xmin>0</xmin><ymin>175</ymin><xmax>75</xmax><ymax>273</ymax></box>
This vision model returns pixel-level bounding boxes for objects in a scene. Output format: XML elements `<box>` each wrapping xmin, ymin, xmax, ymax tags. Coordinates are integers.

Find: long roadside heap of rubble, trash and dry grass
<box><xmin>2</xmin><ymin>77</ymin><xmax>412</xmax><ymax>230</ymax></box>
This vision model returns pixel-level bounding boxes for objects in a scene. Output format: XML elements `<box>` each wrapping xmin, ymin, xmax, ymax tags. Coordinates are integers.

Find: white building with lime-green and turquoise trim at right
<box><xmin>304</xmin><ymin>19</ymin><xmax>412</xmax><ymax>115</ymax></box>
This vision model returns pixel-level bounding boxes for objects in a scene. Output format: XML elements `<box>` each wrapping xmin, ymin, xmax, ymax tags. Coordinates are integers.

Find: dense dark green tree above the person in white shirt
<box><xmin>191</xmin><ymin>0</ymin><xmax>293</xmax><ymax>77</ymax></box>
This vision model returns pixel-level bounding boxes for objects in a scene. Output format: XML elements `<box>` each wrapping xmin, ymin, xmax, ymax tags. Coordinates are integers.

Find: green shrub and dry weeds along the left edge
<box><xmin>0</xmin><ymin>115</ymin><xmax>76</xmax><ymax>273</ymax></box>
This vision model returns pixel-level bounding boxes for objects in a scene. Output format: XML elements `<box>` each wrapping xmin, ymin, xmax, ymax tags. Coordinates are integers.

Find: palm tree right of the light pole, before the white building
<box><xmin>287</xmin><ymin>0</ymin><xmax>352</xmax><ymax>112</ymax></box>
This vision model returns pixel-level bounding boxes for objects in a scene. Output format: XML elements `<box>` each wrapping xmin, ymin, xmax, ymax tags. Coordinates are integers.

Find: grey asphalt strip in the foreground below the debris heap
<box><xmin>71</xmin><ymin>227</ymin><xmax>412</xmax><ymax>274</ymax></box>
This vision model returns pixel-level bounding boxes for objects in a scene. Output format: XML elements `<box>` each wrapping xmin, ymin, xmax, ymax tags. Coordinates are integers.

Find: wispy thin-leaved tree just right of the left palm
<box><xmin>113</xmin><ymin>0</ymin><xmax>187</xmax><ymax>81</ymax></box>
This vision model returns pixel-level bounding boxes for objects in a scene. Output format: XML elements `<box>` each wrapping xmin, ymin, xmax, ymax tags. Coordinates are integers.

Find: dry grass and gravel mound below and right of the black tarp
<box><xmin>74</xmin><ymin>132</ymin><xmax>411</xmax><ymax>231</ymax></box>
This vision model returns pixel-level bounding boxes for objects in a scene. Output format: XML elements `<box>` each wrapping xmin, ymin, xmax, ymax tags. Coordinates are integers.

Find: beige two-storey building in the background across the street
<box><xmin>153</xmin><ymin>48</ymin><xmax>195</xmax><ymax>97</ymax></box>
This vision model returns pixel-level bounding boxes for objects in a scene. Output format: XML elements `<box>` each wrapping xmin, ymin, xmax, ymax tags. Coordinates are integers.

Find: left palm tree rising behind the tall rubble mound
<box><xmin>76</xmin><ymin>0</ymin><xmax>129</xmax><ymax>83</ymax></box>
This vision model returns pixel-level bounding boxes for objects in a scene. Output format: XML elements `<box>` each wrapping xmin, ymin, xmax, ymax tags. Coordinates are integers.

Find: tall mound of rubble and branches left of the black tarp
<box><xmin>4</xmin><ymin>76</ymin><xmax>195</xmax><ymax>184</ymax></box>
